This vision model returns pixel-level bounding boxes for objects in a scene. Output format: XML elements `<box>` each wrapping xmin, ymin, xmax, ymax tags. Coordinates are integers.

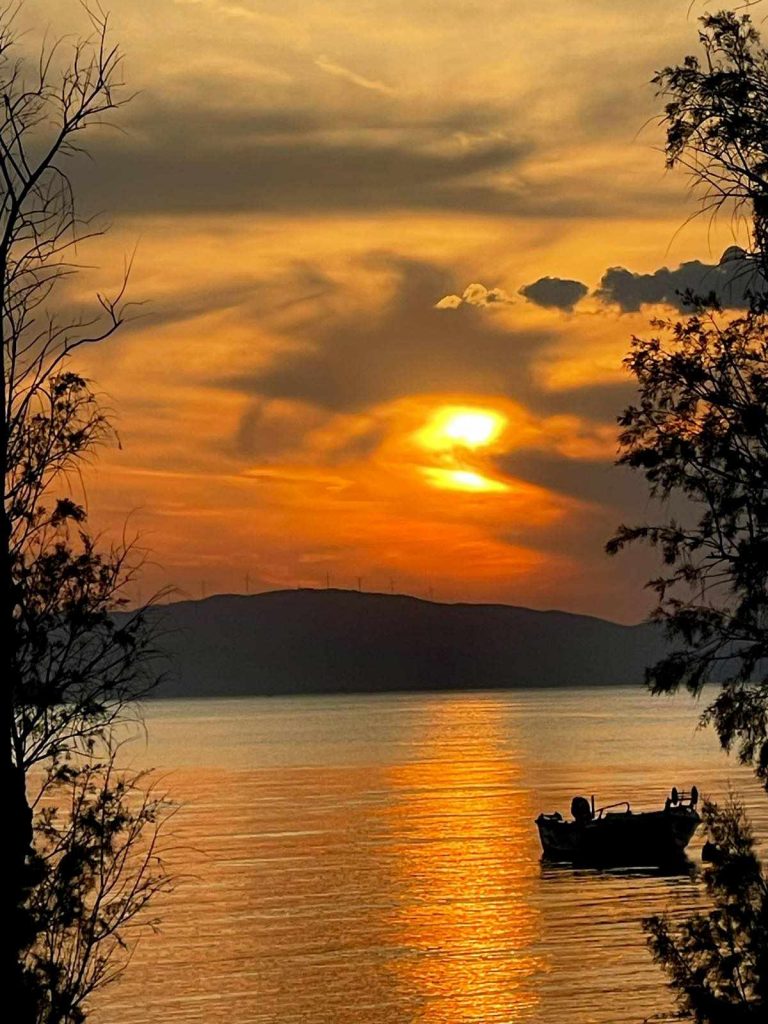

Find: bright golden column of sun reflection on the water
<box><xmin>388</xmin><ymin>699</ymin><xmax>545</xmax><ymax>1024</ymax></box>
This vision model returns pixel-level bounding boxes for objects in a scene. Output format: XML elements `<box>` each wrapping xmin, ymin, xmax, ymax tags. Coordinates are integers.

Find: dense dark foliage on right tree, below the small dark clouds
<box><xmin>607</xmin><ymin>303</ymin><xmax>768</xmax><ymax>783</ymax></box>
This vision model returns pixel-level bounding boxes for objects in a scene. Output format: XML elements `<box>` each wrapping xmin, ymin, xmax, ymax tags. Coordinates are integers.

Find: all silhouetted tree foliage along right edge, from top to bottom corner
<box><xmin>607</xmin><ymin>11</ymin><xmax>768</xmax><ymax>1024</ymax></box>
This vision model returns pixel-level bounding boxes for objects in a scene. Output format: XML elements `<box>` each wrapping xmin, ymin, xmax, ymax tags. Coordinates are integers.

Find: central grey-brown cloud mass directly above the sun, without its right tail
<box><xmin>217</xmin><ymin>255</ymin><xmax>551</xmax><ymax>411</ymax></box>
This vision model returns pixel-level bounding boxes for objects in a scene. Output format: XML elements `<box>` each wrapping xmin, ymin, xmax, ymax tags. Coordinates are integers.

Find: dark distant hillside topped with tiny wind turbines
<box><xmin>137</xmin><ymin>590</ymin><xmax>664</xmax><ymax>696</ymax></box>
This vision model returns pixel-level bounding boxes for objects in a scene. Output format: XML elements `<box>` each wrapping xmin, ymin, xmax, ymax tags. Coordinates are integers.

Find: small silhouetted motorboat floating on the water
<box><xmin>536</xmin><ymin>785</ymin><xmax>701</xmax><ymax>867</ymax></box>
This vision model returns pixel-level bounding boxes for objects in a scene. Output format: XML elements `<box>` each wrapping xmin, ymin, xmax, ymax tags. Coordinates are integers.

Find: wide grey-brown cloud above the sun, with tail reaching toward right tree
<box><xmin>212</xmin><ymin>254</ymin><xmax>647</xmax><ymax>423</ymax></box>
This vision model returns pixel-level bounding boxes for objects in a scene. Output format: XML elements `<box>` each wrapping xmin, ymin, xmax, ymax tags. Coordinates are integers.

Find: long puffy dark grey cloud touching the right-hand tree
<box><xmin>594</xmin><ymin>247</ymin><xmax>765</xmax><ymax>312</ymax></box>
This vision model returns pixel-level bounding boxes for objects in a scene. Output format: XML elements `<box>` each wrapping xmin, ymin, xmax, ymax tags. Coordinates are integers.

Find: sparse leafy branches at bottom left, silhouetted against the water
<box><xmin>25</xmin><ymin>750</ymin><xmax>170</xmax><ymax>1024</ymax></box>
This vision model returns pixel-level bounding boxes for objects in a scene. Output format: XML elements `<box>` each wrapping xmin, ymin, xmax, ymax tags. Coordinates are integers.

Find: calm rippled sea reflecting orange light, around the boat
<box><xmin>94</xmin><ymin>689</ymin><xmax>768</xmax><ymax>1024</ymax></box>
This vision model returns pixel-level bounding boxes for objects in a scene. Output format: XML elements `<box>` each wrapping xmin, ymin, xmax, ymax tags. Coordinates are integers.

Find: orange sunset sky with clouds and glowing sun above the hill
<box><xmin>28</xmin><ymin>0</ymin><xmax>757</xmax><ymax>622</ymax></box>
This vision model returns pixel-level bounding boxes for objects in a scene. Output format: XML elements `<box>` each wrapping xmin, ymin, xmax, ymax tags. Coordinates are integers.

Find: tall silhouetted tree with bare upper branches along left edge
<box><xmin>0</xmin><ymin>8</ymin><xmax>165</xmax><ymax>1024</ymax></box>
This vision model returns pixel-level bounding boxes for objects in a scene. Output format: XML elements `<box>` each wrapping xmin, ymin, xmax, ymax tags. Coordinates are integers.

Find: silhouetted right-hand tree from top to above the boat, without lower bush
<box><xmin>607</xmin><ymin>12</ymin><xmax>768</xmax><ymax>784</ymax></box>
